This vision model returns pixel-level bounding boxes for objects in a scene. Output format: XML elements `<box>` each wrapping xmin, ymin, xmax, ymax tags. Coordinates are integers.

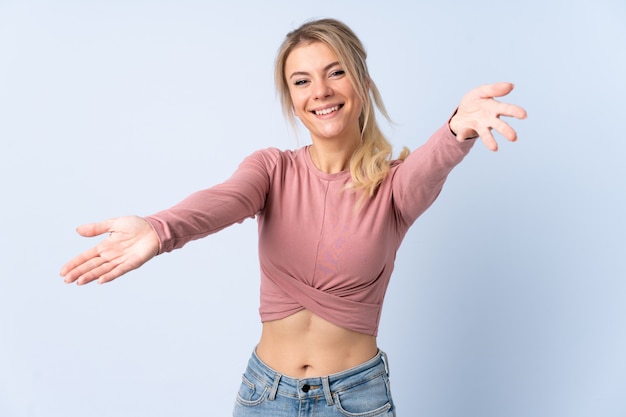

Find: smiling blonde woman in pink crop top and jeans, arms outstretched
<box><xmin>61</xmin><ymin>19</ymin><xmax>526</xmax><ymax>417</ymax></box>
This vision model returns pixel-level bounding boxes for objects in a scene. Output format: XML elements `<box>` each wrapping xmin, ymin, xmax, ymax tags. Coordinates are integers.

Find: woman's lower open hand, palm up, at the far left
<box><xmin>61</xmin><ymin>216</ymin><xmax>159</xmax><ymax>285</ymax></box>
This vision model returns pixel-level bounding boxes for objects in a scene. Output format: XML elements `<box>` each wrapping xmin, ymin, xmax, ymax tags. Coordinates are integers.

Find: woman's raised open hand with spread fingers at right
<box><xmin>449</xmin><ymin>83</ymin><xmax>526</xmax><ymax>151</ymax></box>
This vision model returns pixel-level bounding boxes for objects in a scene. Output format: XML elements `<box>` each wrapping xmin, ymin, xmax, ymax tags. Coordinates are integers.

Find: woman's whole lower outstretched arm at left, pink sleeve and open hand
<box><xmin>61</xmin><ymin>151</ymin><xmax>278</xmax><ymax>285</ymax></box>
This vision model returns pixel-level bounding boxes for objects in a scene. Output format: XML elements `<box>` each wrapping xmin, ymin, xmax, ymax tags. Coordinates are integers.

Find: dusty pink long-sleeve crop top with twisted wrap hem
<box><xmin>146</xmin><ymin>124</ymin><xmax>474</xmax><ymax>335</ymax></box>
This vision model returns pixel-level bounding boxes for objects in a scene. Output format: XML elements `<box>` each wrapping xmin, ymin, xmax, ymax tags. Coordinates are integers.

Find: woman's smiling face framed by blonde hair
<box><xmin>285</xmin><ymin>42</ymin><xmax>362</xmax><ymax>143</ymax></box>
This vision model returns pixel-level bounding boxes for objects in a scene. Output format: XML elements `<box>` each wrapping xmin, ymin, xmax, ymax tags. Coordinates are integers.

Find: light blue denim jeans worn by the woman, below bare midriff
<box><xmin>233</xmin><ymin>351</ymin><xmax>396</xmax><ymax>417</ymax></box>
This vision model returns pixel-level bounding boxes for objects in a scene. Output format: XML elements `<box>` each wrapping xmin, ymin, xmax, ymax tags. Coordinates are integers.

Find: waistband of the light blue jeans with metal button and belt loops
<box><xmin>248</xmin><ymin>350</ymin><xmax>389</xmax><ymax>405</ymax></box>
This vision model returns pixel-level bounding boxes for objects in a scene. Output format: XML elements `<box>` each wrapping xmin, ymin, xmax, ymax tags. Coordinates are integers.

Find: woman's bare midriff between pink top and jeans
<box><xmin>256</xmin><ymin>310</ymin><xmax>378</xmax><ymax>379</ymax></box>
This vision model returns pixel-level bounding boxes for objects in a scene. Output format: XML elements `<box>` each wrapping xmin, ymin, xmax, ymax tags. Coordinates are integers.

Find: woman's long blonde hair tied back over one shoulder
<box><xmin>274</xmin><ymin>19</ymin><xmax>409</xmax><ymax>199</ymax></box>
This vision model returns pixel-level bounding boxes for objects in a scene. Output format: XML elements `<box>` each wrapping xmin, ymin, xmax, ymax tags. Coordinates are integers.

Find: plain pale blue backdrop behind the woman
<box><xmin>0</xmin><ymin>0</ymin><xmax>626</xmax><ymax>417</ymax></box>
